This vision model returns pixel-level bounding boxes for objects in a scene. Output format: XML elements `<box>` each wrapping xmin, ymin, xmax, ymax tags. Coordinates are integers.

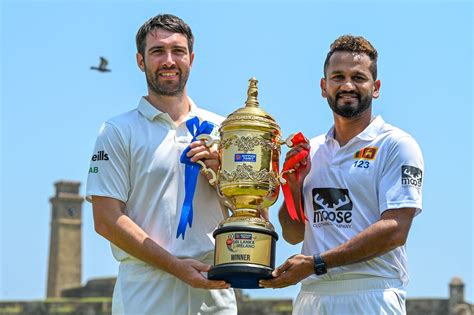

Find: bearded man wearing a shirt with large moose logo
<box><xmin>261</xmin><ymin>35</ymin><xmax>423</xmax><ymax>315</ymax></box>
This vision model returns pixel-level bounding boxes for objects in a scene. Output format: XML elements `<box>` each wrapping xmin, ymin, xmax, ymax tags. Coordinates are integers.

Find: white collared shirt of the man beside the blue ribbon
<box><xmin>86</xmin><ymin>98</ymin><xmax>224</xmax><ymax>261</ymax></box>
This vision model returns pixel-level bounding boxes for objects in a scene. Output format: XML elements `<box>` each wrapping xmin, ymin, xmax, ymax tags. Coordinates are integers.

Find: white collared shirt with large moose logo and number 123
<box><xmin>302</xmin><ymin>116</ymin><xmax>424</xmax><ymax>285</ymax></box>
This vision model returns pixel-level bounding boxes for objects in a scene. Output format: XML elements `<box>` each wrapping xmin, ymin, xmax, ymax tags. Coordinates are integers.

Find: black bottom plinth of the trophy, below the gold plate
<box><xmin>207</xmin><ymin>264</ymin><xmax>273</xmax><ymax>289</ymax></box>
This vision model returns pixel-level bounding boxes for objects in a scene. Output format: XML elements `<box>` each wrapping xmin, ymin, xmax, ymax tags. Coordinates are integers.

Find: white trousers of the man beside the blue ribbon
<box><xmin>112</xmin><ymin>259</ymin><xmax>237</xmax><ymax>315</ymax></box>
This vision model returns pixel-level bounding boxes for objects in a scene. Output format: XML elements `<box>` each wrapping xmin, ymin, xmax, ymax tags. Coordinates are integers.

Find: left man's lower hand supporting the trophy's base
<box><xmin>173</xmin><ymin>259</ymin><xmax>230</xmax><ymax>290</ymax></box>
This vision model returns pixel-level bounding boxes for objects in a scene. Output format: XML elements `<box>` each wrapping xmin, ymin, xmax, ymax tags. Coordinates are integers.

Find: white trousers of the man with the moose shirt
<box><xmin>293</xmin><ymin>278</ymin><xmax>406</xmax><ymax>315</ymax></box>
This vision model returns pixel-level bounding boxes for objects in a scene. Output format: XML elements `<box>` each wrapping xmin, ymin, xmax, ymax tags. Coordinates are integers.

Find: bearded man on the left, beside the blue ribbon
<box><xmin>86</xmin><ymin>14</ymin><xmax>237</xmax><ymax>314</ymax></box>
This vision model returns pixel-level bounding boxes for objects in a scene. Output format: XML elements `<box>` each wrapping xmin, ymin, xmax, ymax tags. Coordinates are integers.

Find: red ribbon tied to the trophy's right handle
<box><xmin>281</xmin><ymin>132</ymin><xmax>309</xmax><ymax>221</ymax></box>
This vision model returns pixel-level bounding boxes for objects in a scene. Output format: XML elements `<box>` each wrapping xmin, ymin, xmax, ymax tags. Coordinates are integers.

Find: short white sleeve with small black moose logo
<box><xmin>378</xmin><ymin>135</ymin><xmax>424</xmax><ymax>214</ymax></box>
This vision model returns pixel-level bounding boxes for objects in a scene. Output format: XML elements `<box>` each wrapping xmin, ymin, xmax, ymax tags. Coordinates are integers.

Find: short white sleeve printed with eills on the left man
<box><xmin>86</xmin><ymin>122</ymin><xmax>130</xmax><ymax>202</ymax></box>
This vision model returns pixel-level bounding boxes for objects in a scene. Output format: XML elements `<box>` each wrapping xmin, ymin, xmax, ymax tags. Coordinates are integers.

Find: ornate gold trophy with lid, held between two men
<box><xmin>198</xmin><ymin>78</ymin><xmax>292</xmax><ymax>289</ymax></box>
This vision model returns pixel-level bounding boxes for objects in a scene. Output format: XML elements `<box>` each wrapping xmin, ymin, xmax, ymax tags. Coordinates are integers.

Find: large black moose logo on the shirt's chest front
<box><xmin>312</xmin><ymin>188</ymin><xmax>353</xmax><ymax>229</ymax></box>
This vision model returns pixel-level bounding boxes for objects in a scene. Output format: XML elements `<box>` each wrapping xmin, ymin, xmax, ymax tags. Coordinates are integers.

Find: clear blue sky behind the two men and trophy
<box><xmin>0</xmin><ymin>0</ymin><xmax>474</xmax><ymax>302</ymax></box>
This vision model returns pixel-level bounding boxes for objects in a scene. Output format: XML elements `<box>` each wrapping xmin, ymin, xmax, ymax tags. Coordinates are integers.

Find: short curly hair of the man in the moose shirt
<box><xmin>324</xmin><ymin>35</ymin><xmax>378</xmax><ymax>80</ymax></box>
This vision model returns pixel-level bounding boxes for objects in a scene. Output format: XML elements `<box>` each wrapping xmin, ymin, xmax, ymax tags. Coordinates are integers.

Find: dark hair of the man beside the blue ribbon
<box><xmin>135</xmin><ymin>14</ymin><xmax>194</xmax><ymax>56</ymax></box>
